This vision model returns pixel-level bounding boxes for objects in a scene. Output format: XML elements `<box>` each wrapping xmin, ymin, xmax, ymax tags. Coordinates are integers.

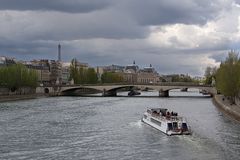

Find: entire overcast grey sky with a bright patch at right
<box><xmin>0</xmin><ymin>0</ymin><xmax>240</xmax><ymax>75</ymax></box>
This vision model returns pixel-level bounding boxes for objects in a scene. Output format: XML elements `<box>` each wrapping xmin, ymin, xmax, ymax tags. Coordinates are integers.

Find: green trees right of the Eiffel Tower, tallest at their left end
<box><xmin>70</xmin><ymin>59</ymin><xmax>98</xmax><ymax>84</ymax></box>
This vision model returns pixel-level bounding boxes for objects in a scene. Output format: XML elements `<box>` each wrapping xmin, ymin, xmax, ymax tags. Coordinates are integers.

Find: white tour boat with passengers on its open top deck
<box><xmin>142</xmin><ymin>108</ymin><xmax>191</xmax><ymax>136</ymax></box>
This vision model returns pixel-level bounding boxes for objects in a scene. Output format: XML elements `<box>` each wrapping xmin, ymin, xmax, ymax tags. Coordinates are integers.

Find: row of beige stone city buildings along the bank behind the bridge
<box><xmin>0</xmin><ymin>56</ymin><xmax>203</xmax><ymax>85</ymax></box>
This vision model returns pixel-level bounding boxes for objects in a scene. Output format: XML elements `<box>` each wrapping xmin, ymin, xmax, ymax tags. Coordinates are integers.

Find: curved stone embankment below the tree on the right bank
<box><xmin>213</xmin><ymin>95</ymin><xmax>240</xmax><ymax>122</ymax></box>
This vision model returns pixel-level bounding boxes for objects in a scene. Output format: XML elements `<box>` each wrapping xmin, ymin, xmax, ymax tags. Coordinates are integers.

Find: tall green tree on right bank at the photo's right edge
<box><xmin>216</xmin><ymin>52</ymin><xmax>240</xmax><ymax>103</ymax></box>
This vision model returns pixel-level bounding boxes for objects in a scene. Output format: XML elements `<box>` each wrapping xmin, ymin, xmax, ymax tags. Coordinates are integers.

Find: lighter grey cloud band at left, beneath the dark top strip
<box><xmin>0</xmin><ymin>10</ymin><xmax>149</xmax><ymax>41</ymax></box>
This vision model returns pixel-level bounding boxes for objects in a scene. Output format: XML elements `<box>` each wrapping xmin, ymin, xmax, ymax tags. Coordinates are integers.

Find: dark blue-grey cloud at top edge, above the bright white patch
<box><xmin>119</xmin><ymin>0</ymin><xmax>224</xmax><ymax>26</ymax></box>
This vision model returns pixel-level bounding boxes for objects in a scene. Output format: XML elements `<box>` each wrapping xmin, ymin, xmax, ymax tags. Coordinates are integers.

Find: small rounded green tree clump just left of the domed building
<box><xmin>101</xmin><ymin>72</ymin><xmax>123</xmax><ymax>83</ymax></box>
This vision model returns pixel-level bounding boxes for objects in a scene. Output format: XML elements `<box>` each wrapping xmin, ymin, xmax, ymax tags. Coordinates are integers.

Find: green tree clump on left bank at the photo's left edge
<box><xmin>0</xmin><ymin>64</ymin><xmax>38</xmax><ymax>90</ymax></box>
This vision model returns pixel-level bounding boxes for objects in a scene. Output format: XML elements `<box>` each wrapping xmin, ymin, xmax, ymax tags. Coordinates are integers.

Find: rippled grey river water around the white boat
<box><xmin>0</xmin><ymin>90</ymin><xmax>240</xmax><ymax>160</ymax></box>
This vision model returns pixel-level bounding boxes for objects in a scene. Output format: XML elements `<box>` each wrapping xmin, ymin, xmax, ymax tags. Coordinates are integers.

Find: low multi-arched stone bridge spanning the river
<box><xmin>37</xmin><ymin>83</ymin><xmax>217</xmax><ymax>97</ymax></box>
